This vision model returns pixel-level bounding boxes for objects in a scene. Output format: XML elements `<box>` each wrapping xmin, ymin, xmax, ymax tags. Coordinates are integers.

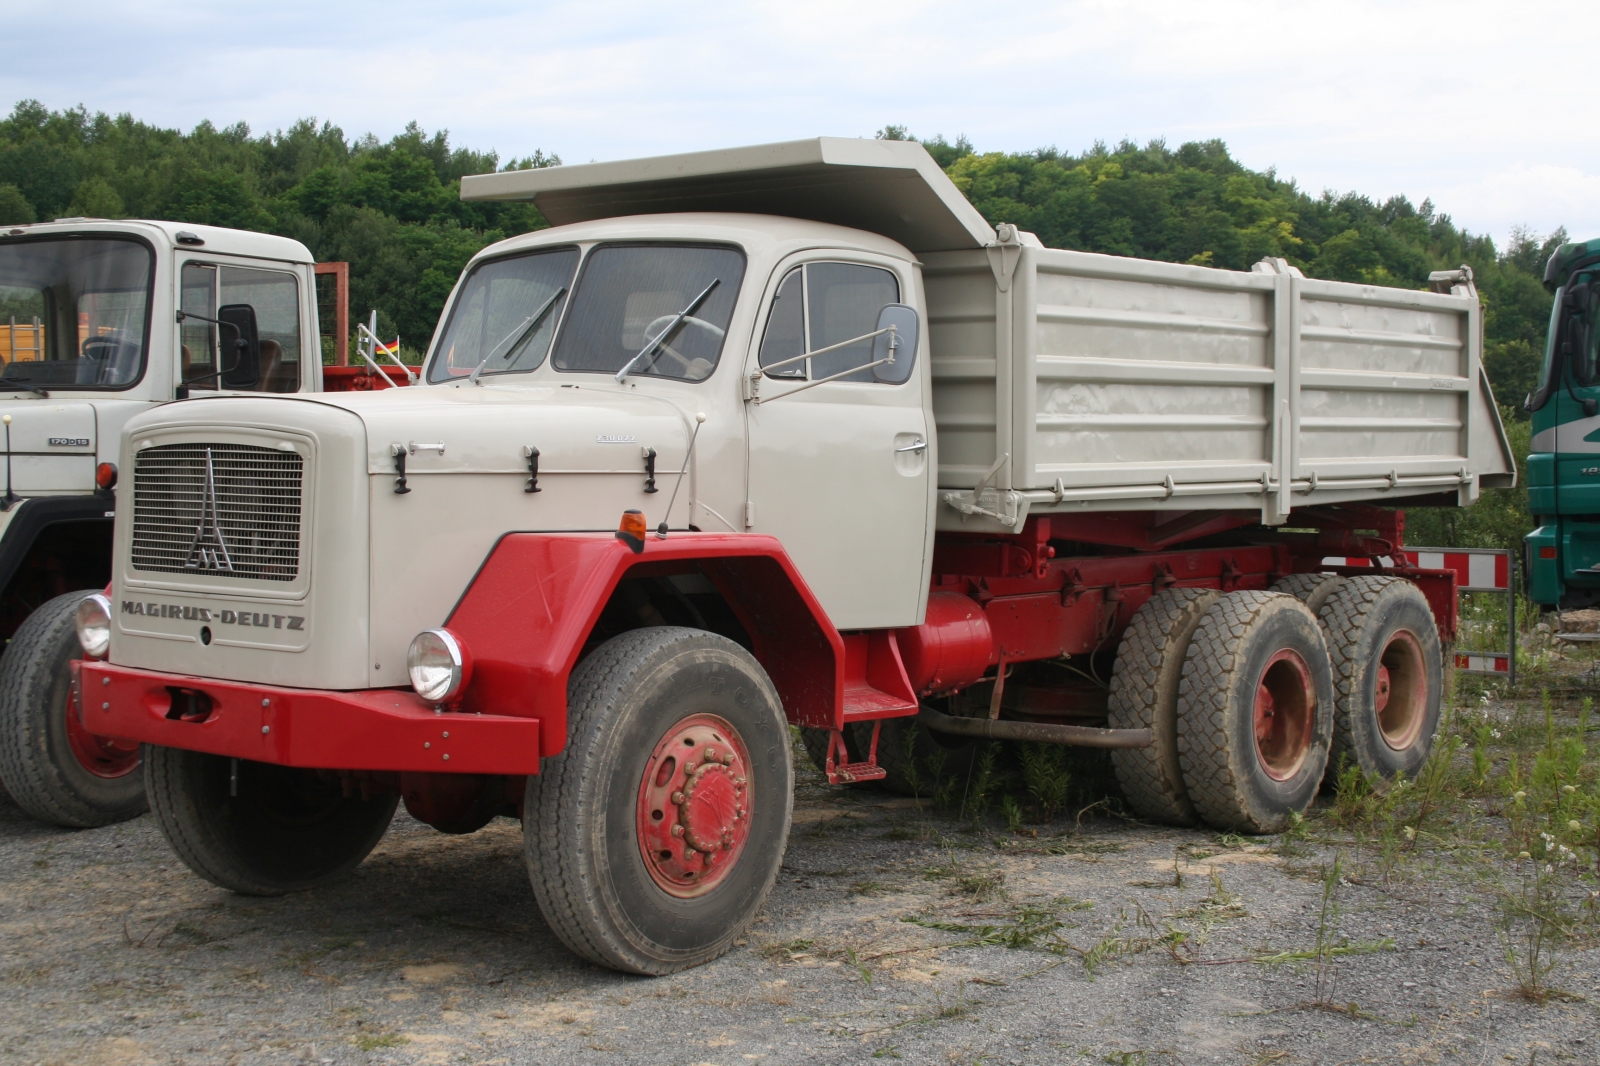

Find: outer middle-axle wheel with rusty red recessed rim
<box><xmin>1178</xmin><ymin>591</ymin><xmax>1333</xmax><ymax>832</ymax></box>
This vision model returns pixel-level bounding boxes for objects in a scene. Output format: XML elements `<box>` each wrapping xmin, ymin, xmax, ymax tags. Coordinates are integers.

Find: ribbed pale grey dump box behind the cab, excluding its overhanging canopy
<box><xmin>922</xmin><ymin>234</ymin><xmax>1515</xmax><ymax>525</ymax></box>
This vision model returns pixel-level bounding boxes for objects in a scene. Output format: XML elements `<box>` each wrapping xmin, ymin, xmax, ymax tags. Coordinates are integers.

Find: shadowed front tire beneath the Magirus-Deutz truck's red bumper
<box><xmin>144</xmin><ymin>744</ymin><xmax>400</xmax><ymax>896</ymax></box>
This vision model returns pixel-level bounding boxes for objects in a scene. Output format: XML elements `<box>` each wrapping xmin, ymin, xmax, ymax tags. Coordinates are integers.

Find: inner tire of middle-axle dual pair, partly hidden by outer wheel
<box><xmin>1107</xmin><ymin>589</ymin><xmax>1222</xmax><ymax>826</ymax></box>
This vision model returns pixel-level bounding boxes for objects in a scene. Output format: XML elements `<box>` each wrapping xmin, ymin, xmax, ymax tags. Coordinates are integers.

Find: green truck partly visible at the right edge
<box><xmin>1526</xmin><ymin>240</ymin><xmax>1600</xmax><ymax>610</ymax></box>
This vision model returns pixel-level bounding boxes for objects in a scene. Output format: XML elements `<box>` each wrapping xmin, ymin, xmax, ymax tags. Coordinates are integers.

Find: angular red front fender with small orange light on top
<box><xmin>445</xmin><ymin>533</ymin><xmax>845</xmax><ymax>745</ymax></box>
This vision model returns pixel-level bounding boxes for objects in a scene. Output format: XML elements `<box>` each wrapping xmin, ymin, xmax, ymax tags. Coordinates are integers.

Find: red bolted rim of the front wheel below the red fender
<box><xmin>637</xmin><ymin>714</ymin><xmax>750</xmax><ymax>900</ymax></box>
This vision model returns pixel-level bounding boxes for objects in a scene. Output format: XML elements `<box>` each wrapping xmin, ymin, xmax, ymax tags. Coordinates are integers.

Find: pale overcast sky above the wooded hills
<box><xmin>9</xmin><ymin>0</ymin><xmax>1600</xmax><ymax>249</ymax></box>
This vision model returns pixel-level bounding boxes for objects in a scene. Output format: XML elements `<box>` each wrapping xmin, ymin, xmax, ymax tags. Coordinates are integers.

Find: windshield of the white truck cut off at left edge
<box><xmin>0</xmin><ymin>237</ymin><xmax>155</xmax><ymax>389</ymax></box>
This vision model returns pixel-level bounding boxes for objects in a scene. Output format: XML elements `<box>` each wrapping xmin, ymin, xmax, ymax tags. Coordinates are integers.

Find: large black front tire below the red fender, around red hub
<box><xmin>523</xmin><ymin>626</ymin><xmax>794</xmax><ymax>975</ymax></box>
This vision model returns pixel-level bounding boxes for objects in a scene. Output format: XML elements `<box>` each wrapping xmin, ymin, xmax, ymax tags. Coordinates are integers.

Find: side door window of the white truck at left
<box><xmin>179</xmin><ymin>262</ymin><xmax>301</xmax><ymax>392</ymax></box>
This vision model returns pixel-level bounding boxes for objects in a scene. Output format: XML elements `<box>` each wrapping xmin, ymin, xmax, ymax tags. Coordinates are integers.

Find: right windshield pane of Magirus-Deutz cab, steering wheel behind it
<box><xmin>554</xmin><ymin>243</ymin><xmax>744</xmax><ymax>381</ymax></box>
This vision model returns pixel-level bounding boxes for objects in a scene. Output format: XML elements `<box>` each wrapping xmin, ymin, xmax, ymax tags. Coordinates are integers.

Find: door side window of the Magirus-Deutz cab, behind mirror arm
<box><xmin>760</xmin><ymin>262</ymin><xmax>909</xmax><ymax>381</ymax></box>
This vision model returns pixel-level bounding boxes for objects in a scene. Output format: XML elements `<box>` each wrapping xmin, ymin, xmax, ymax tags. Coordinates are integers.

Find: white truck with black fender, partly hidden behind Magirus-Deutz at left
<box><xmin>0</xmin><ymin>218</ymin><xmax>406</xmax><ymax>826</ymax></box>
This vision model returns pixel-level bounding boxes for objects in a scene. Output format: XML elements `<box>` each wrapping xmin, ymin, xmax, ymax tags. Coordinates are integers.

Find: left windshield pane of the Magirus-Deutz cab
<box><xmin>427</xmin><ymin>248</ymin><xmax>578</xmax><ymax>383</ymax></box>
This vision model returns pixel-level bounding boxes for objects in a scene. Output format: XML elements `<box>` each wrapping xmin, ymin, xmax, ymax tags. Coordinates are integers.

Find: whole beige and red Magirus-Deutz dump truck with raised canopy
<box><xmin>74</xmin><ymin>138</ymin><xmax>1514</xmax><ymax>973</ymax></box>
